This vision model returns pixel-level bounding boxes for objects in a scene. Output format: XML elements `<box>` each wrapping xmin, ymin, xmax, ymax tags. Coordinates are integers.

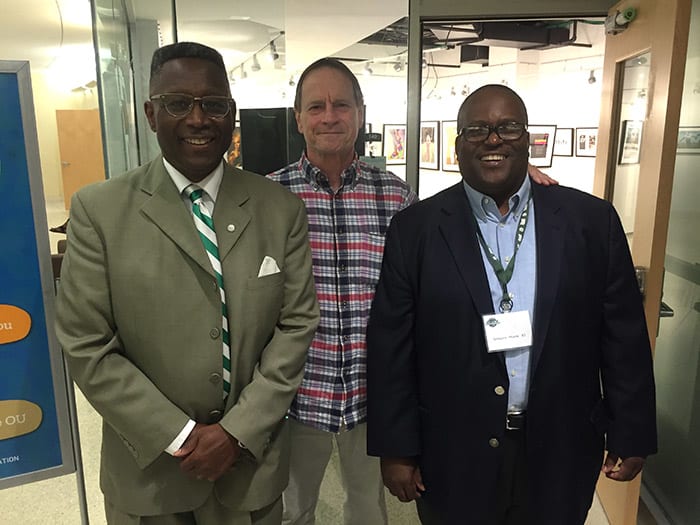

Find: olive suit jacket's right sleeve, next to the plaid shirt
<box><xmin>221</xmin><ymin>196</ymin><xmax>320</xmax><ymax>458</ymax></box>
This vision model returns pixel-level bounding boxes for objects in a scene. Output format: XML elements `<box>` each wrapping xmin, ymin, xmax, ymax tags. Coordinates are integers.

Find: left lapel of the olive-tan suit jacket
<box><xmin>141</xmin><ymin>156</ymin><xmax>214</xmax><ymax>276</ymax></box>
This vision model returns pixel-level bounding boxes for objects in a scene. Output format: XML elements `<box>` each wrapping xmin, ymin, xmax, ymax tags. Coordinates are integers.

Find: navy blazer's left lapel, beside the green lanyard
<box><xmin>439</xmin><ymin>182</ymin><xmax>493</xmax><ymax>315</ymax></box>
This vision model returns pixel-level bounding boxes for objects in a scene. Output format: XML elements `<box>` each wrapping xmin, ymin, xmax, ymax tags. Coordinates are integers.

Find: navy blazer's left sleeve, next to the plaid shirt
<box><xmin>367</xmin><ymin>217</ymin><xmax>421</xmax><ymax>457</ymax></box>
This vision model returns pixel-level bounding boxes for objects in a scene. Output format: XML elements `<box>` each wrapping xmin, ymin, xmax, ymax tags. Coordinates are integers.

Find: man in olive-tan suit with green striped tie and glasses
<box><xmin>57</xmin><ymin>43</ymin><xmax>319</xmax><ymax>525</ymax></box>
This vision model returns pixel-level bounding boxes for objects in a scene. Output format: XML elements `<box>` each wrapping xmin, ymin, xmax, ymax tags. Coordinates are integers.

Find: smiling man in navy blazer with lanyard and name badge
<box><xmin>367</xmin><ymin>85</ymin><xmax>656</xmax><ymax>525</ymax></box>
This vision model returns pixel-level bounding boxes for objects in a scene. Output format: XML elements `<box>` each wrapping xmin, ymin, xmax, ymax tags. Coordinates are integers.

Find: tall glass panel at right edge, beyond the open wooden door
<box><xmin>643</xmin><ymin>0</ymin><xmax>700</xmax><ymax>524</ymax></box>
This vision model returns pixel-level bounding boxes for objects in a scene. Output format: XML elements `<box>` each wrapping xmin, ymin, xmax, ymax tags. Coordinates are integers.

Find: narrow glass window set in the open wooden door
<box><xmin>612</xmin><ymin>53</ymin><xmax>651</xmax><ymax>245</ymax></box>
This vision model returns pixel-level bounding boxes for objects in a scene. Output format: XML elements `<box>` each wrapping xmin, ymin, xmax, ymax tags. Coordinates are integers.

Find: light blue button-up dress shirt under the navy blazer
<box><xmin>464</xmin><ymin>176</ymin><xmax>537</xmax><ymax>412</ymax></box>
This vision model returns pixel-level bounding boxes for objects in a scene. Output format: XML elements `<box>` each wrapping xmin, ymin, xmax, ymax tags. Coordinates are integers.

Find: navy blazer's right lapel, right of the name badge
<box><xmin>530</xmin><ymin>184</ymin><xmax>566</xmax><ymax>377</ymax></box>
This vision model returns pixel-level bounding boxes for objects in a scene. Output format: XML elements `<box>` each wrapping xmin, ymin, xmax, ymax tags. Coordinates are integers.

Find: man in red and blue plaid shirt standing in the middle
<box><xmin>269</xmin><ymin>58</ymin><xmax>417</xmax><ymax>525</ymax></box>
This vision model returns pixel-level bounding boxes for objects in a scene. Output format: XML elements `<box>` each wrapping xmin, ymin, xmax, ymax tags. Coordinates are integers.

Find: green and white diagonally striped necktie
<box><xmin>184</xmin><ymin>184</ymin><xmax>231</xmax><ymax>399</ymax></box>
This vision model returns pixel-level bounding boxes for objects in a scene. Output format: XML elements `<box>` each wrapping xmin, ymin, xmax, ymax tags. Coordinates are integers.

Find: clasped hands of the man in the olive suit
<box><xmin>173</xmin><ymin>423</ymin><xmax>241</xmax><ymax>481</ymax></box>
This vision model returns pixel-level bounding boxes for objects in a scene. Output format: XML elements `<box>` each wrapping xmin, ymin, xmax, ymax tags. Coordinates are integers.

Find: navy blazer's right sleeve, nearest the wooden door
<box><xmin>601</xmin><ymin>205</ymin><xmax>657</xmax><ymax>458</ymax></box>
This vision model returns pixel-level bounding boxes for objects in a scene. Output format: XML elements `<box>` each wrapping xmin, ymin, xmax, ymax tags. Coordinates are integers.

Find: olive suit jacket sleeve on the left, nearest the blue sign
<box><xmin>56</xmin><ymin>188</ymin><xmax>189</xmax><ymax>468</ymax></box>
